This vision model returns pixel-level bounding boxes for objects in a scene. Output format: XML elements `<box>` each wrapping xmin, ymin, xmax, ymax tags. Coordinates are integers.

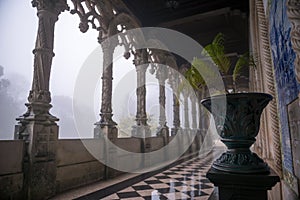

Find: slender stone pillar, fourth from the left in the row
<box><xmin>156</xmin><ymin>65</ymin><xmax>169</xmax><ymax>143</ymax></box>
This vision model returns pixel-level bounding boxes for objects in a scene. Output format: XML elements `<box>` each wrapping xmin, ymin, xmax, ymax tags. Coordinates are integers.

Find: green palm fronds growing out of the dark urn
<box><xmin>185</xmin><ymin>33</ymin><xmax>255</xmax><ymax>93</ymax></box>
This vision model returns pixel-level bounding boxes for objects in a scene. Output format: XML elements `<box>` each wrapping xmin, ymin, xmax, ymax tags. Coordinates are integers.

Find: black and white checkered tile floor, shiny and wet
<box><xmin>101</xmin><ymin>157</ymin><xmax>214</xmax><ymax>200</ymax></box>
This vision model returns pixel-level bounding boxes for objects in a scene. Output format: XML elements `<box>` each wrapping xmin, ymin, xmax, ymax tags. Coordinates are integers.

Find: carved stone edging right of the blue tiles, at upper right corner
<box><xmin>287</xmin><ymin>0</ymin><xmax>300</xmax><ymax>82</ymax></box>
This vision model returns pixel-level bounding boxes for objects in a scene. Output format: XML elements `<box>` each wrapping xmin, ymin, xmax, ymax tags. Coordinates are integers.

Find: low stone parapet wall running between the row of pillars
<box><xmin>0</xmin><ymin>133</ymin><xmax>200</xmax><ymax>199</ymax></box>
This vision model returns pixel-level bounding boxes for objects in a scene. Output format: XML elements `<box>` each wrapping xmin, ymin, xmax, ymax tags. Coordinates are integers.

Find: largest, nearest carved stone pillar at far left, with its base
<box><xmin>15</xmin><ymin>0</ymin><xmax>68</xmax><ymax>199</ymax></box>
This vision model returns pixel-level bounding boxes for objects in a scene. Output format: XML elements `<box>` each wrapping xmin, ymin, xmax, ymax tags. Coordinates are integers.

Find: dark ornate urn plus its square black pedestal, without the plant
<box><xmin>201</xmin><ymin>93</ymin><xmax>280</xmax><ymax>200</ymax></box>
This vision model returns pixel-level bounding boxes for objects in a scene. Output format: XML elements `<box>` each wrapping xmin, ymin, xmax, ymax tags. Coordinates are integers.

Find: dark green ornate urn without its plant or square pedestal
<box><xmin>201</xmin><ymin>93</ymin><xmax>272</xmax><ymax>174</ymax></box>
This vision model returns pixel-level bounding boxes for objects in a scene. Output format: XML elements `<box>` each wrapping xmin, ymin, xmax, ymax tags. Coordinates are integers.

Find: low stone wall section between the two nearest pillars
<box><xmin>56</xmin><ymin>139</ymin><xmax>105</xmax><ymax>192</ymax></box>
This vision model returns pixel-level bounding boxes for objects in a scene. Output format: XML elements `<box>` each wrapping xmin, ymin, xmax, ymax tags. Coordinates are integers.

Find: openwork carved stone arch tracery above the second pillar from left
<box><xmin>71</xmin><ymin>0</ymin><xmax>140</xmax><ymax>43</ymax></box>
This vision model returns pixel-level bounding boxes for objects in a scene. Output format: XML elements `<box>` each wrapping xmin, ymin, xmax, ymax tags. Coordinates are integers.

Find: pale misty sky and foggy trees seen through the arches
<box><xmin>0</xmin><ymin>0</ymin><xmax>191</xmax><ymax>139</ymax></box>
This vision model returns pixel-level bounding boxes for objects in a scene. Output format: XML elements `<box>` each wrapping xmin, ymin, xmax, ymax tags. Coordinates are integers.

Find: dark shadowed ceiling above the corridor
<box><xmin>123</xmin><ymin>0</ymin><xmax>249</xmax><ymax>55</ymax></box>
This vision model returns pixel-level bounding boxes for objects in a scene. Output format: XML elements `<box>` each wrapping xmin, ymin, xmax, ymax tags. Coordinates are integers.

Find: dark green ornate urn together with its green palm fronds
<box><xmin>185</xmin><ymin>34</ymin><xmax>272</xmax><ymax>174</ymax></box>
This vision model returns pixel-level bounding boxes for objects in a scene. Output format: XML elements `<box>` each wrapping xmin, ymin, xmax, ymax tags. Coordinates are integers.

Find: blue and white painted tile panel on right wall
<box><xmin>268</xmin><ymin>0</ymin><xmax>300</xmax><ymax>174</ymax></box>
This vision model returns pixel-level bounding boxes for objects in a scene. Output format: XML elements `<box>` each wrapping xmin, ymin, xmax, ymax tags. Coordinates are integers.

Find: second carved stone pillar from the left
<box><xmin>94</xmin><ymin>40</ymin><xmax>118</xmax><ymax>139</ymax></box>
